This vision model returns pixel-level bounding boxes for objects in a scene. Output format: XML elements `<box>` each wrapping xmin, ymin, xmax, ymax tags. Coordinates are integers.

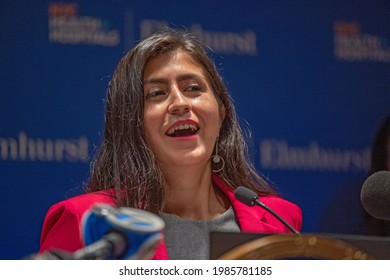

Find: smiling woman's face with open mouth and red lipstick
<box><xmin>143</xmin><ymin>51</ymin><xmax>224</xmax><ymax>169</ymax></box>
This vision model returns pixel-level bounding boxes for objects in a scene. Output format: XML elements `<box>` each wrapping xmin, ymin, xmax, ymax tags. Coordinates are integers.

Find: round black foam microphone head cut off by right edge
<box><xmin>360</xmin><ymin>171</ymin><xmax>390</xmax><ymax>221</ymax></box>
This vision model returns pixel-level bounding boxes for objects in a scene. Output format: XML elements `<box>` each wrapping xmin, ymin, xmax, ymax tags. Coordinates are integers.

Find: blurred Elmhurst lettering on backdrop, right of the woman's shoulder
<box><xmin>260</xmin><ymin>139</ymin><xmax>370</xmax><ymax>172</ymax></box>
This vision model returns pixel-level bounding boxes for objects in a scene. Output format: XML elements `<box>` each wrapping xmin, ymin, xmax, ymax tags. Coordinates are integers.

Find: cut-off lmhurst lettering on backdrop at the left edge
<box><xmin>0</xmin><ymin>131</ymin><xmax>89</xmax><ymax>162</ymax></box>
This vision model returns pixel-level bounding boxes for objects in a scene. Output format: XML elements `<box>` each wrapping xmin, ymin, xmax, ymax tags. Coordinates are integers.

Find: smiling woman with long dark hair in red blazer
<box><xmin>40</xmin><ymin>29</ymin><xmax>302</xmax><ymax>259</ymax></box>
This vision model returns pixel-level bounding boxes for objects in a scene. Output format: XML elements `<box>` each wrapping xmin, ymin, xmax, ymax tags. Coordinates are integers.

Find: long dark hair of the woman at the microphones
<box><xmin>87</xmin><ymin>28</ymin><xmax>278</xmax><ymax>214</ymax></box>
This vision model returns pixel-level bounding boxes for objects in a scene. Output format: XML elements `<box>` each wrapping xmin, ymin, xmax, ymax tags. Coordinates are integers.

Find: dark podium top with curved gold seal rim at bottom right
<box><xmin>210</xmin><ymin>232</ymin><xmax>390</xmax><ymax>260</ymax></box>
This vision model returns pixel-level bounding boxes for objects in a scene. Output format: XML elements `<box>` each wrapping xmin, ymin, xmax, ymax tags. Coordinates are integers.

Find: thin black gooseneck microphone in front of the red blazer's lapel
<box><xmin>234</xmin><ymin>186</ymin><xmax>300</xmax><ymax>235</ymax></box>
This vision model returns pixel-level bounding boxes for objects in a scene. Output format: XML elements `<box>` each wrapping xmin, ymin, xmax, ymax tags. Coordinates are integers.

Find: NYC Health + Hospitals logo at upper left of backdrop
<box><xmin>48</xmin><ymin>3</ymin><xmax>120</xmax><ymax>47</ymax></box>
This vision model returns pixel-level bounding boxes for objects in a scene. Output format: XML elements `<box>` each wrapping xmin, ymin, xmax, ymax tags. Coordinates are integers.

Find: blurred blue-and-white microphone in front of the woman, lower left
<box><xmin>30</xmin><ymin>204</ymin><xmax>165</xmax><ymax>260</ymax></box>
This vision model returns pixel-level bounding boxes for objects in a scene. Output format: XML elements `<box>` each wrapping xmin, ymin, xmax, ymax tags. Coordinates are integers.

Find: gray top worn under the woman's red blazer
<box><xmin>161</xmin><ymin>207</ymin><xmax>240</xmax><ymax>260</ymax></box>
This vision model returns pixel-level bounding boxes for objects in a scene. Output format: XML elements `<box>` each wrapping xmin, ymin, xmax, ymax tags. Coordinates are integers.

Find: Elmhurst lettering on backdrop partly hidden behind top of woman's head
<box><xmin>140</xmin><ymin>19</ymin><xmax>257</xmax><ymax>55</ymax></box>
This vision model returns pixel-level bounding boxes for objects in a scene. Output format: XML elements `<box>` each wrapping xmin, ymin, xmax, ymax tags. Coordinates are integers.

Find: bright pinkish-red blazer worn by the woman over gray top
<box><xmin>39</xmin><ymin>175</ymin><xmax>302</xmax><ymax>260</ymax></box>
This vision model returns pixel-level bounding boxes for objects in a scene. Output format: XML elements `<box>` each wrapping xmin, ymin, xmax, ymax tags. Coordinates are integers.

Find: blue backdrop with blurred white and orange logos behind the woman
<box><xmin>0</xmin><ymin>0</ymin><xmax>390</xmax><ymax>259</ymax></box>
